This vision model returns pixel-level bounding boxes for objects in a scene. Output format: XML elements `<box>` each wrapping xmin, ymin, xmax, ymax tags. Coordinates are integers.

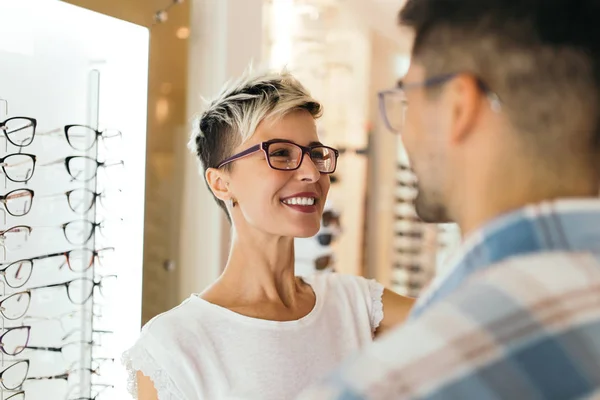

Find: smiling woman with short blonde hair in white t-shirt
<box><xmin>124</xmin><ymin>72</ymin><xmax>412</xmax><ymax>400</ymax></box>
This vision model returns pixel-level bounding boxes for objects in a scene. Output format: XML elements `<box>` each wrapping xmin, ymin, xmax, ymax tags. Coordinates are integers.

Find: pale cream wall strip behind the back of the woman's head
<box><xmin>178</xmin><ymin>0</ymin><xmax>263</xmax><ymax>299</ymax></box>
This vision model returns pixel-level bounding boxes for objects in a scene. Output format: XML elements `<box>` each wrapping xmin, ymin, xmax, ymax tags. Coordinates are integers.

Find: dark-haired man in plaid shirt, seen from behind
<box><xmin>301</xmin><ymin>0</ymin><xmax>600</xmax><ymax>400</ymax></box>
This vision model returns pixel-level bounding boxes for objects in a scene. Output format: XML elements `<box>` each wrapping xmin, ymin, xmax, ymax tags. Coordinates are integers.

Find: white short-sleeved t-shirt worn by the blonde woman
<box><xmin>123</xmin><ymin>273</ymin><xmax>383</xmax><ymax>400</ymax></box>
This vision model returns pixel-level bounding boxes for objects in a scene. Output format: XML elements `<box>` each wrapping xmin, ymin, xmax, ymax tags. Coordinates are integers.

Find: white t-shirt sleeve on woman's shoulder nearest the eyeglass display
<box><xmin>121</xmin><ymin>321</ymin><xmax>184</xmax><ymax>400</ymax></box>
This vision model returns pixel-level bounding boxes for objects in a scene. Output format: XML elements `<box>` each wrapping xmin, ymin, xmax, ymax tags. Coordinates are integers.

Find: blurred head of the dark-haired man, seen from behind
<box><xmin>400</xmin><ymin>0</ymin><xmax>600</xmax><ymax>227</ymax></box>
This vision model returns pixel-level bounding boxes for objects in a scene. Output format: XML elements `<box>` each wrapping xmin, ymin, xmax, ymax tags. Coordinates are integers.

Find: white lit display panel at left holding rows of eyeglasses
<box><xmin>0</xmin><ymin>0</ymin><xmax>149</xmax><ymax>400</ymax></box>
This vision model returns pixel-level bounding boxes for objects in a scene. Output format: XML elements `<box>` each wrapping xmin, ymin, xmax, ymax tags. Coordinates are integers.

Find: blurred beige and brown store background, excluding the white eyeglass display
<box><xmin>58</xmin><ymin>0</ymin><xmax>458</xmax><ymax>322</ymax></box>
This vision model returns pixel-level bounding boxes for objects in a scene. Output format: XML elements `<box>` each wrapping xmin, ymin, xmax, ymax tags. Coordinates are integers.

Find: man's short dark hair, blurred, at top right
<box><xmin>399</xmin><ymin>0</ymin><xmax>600</xmax><ymax>157</ymax></box>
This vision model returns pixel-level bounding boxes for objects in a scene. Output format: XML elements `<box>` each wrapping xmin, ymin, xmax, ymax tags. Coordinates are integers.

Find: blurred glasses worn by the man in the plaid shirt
<box><xmin>378</xmin><ymin>73</ymin><xmax>501</xmax><ymax>133</ymax></box>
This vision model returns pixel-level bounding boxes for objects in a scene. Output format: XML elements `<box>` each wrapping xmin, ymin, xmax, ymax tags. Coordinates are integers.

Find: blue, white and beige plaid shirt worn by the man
<box><xmin>300</xmin><ymin>199</ymin><xmax>600</xmax><ymax>400</ymax></box>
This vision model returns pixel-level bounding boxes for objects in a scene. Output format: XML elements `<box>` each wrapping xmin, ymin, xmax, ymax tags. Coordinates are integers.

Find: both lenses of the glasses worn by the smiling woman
<box><xmin>267</xmin><ymin>142</ymin><xmax>337</xmax><ymax>173</ymax></box>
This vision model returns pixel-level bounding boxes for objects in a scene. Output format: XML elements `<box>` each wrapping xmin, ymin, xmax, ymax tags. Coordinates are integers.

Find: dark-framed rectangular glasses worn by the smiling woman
<box><xmin>217</xmin><ymin>139</ymin><xmax>340</xmax><ymax>174</ymax></box>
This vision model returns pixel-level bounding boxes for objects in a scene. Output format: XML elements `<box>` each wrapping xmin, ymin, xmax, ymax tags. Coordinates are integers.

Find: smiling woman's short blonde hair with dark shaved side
<box><xmin>189</xmin><ymin>69</ymin><xmax>323</xmax><ymax>219</ymax></box>
